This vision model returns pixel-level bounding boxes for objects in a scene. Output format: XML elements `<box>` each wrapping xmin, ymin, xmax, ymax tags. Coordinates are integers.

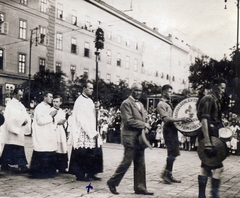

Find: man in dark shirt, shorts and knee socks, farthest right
<box><xmin>197</xmin><ymin>78</ymin><xmax>226</xmax><ymax>198</ymax></box>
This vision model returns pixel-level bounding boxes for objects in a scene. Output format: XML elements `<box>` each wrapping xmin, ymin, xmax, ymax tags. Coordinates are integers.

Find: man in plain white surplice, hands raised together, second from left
<box><xmin>30</xmin><ymin>91</ymin><xmax>58</xmax><ymax>178</ymax></box>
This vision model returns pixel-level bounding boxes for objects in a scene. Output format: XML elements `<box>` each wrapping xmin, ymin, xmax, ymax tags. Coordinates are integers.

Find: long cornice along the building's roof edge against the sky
<box><xmin>85</xmin><ymin>0</ymin><xmax>172</xmax><ymax>45</ymax></box>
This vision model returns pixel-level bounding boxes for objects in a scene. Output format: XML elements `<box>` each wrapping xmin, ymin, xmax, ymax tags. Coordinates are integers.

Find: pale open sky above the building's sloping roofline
<box><xmin>103</xmin><ymin>0</ymin><xmax>237</xmax><ymax>60</ymax></box>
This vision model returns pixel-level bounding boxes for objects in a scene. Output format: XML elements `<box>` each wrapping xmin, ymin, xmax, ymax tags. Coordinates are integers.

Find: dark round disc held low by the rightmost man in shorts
<box><xmin>197</xmin><ymin>137</ymin><xmax>228</xmax><ymax>166</ymax></box>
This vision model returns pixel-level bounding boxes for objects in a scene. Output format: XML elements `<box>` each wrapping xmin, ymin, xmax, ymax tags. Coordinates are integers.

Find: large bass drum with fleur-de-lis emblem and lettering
<box><xmin>173</xmin><ymin>97</ymin><xmax>202</xmax><ymax>136</ymax></box>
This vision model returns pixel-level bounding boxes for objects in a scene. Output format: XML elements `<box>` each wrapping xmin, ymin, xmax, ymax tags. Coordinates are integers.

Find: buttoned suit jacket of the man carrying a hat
<box><xmin>120</xmin><ymin>97</ymin><xmax>147</xmax><ymax>147</ymax></box>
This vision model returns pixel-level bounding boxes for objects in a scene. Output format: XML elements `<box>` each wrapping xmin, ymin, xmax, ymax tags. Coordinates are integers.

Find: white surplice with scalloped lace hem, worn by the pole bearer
<box><xmin>69</xmin><ymin>95</ymin><xmax>102</xmax><ymax>149</ymax></box>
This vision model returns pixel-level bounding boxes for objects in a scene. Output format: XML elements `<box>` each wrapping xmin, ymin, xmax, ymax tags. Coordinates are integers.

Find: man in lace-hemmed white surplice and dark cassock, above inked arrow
<box><xmin>69</xmin><ymin>81</ymin><xmax>103</xmax><ymax>181</ymax></box>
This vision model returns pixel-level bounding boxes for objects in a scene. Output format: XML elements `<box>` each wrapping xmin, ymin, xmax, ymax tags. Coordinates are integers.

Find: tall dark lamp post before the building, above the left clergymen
<box><xmin>28</xmin><ymin>27</ymin><xmax>38</xmax><ymax>110</ymax></box>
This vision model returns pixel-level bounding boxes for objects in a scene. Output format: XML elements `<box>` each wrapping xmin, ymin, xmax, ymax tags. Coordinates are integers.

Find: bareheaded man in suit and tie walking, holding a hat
<box><xmin>107</xmin><ymin>83</ymin><xmax>153</xmax><ymax>195</ymax></box>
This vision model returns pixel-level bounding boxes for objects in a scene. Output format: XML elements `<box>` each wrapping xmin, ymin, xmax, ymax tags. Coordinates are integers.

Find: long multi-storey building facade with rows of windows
<box><xmin>0</xmin><ymin>0</ymin><xmax>206</xmax><ymax>105</ymax></box>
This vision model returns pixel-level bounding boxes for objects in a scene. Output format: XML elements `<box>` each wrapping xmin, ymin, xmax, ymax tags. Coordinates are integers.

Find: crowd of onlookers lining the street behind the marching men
<box><xmin>99</xmin><ymin>109</ymin><xmax>240</xmax><ymax>155</ymax></box>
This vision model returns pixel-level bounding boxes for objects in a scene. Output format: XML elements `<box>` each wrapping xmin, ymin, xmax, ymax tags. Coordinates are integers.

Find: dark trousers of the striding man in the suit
<box><xmin>109</xmin><ymin>146</ymin><xmax>146</xmax><ymax>191</ymax></box>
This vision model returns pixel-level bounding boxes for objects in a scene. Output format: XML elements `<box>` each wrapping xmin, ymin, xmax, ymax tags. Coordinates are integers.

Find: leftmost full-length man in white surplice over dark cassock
<box><xmin>1</xmin><ymin>88</ymin><xmax>31</xmax><ymax>172</ymax></box>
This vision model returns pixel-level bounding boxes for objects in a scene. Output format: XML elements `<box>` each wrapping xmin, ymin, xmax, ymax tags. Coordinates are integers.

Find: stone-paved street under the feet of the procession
<box><xmin>0</xmin><ymin>137</ymin><xmax>240</xmax><ymax>198</ymax></box>
